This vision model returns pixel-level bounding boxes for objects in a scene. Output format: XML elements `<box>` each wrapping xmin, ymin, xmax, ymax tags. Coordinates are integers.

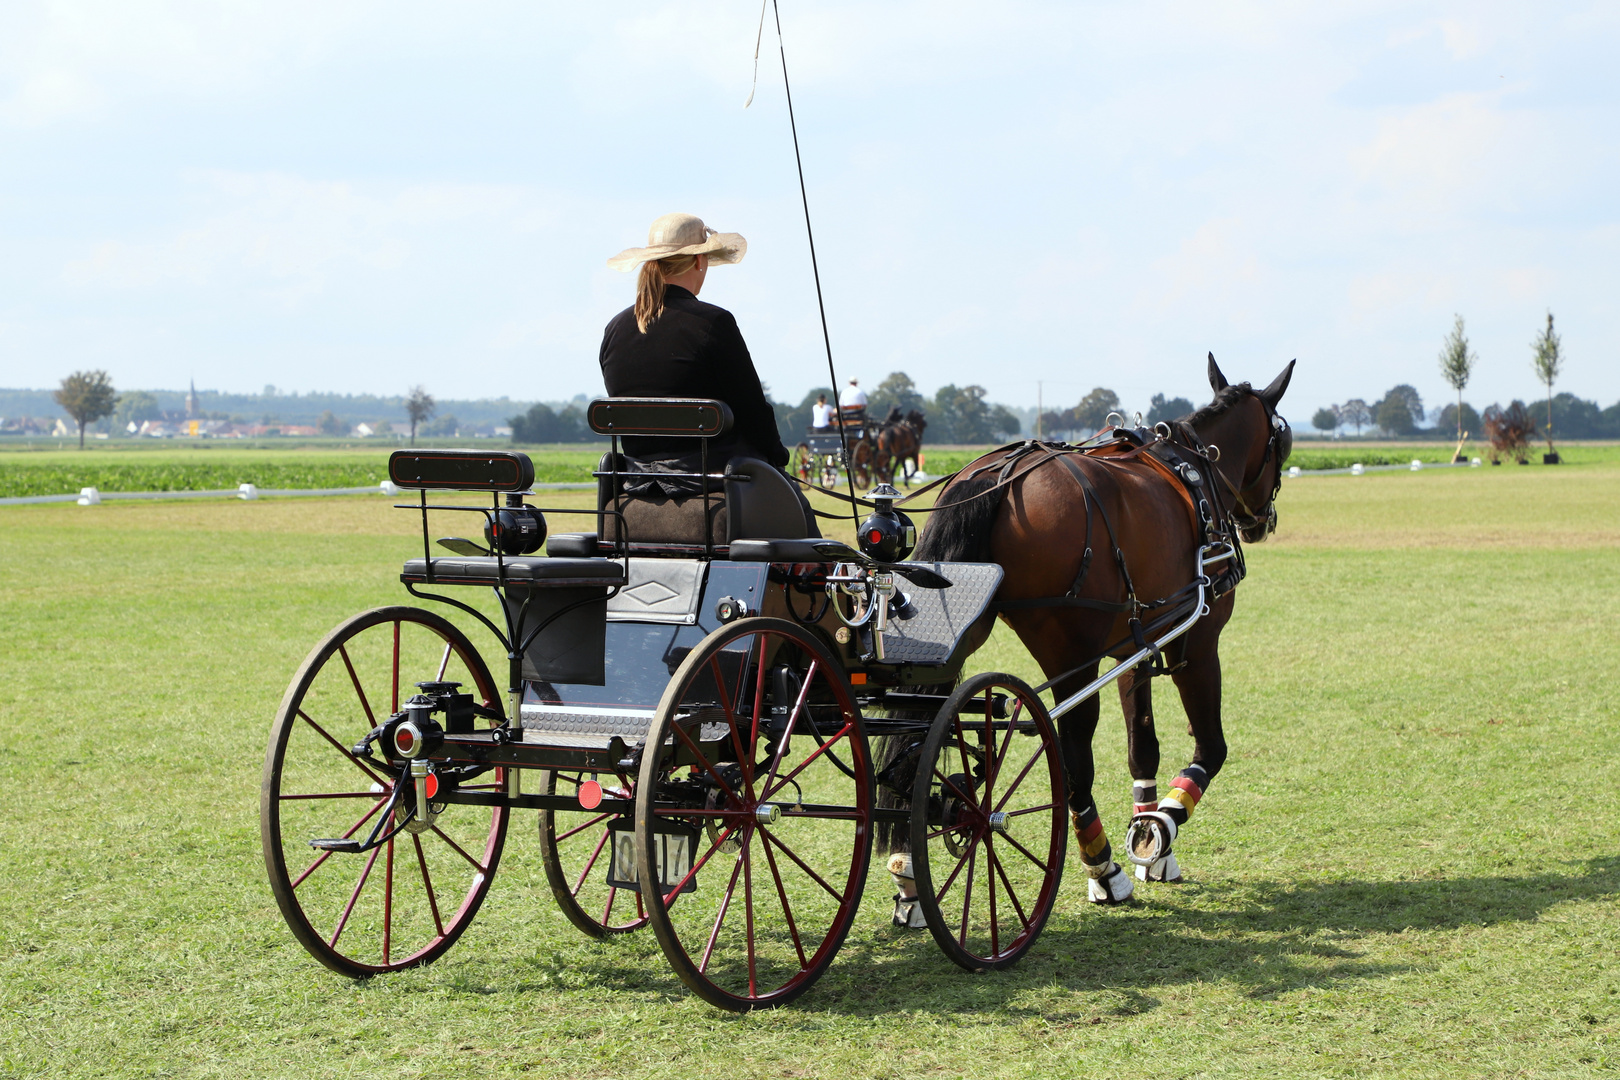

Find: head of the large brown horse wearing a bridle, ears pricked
<box><xmin>1192</xmin><ymin>353</ymin><xmax>1294</xmax><ymax>544</ymax></box>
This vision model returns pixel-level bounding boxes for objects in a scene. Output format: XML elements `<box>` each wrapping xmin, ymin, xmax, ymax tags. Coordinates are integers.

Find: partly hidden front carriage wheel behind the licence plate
<box><xmin>539</xmin><ymin>769</ymin><xmax>646</xmax><ymax>938</ymax></box>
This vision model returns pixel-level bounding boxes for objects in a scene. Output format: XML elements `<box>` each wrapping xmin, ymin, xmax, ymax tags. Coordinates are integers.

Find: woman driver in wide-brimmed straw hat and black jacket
<box><xmin>599</xmin><ymin>214</ymin><xmax>787</xmax><ymax>470</ymax></box>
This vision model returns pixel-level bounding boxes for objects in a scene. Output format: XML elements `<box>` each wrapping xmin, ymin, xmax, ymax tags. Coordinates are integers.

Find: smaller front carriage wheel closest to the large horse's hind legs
<box><xmin>910</xmin><ymin>672</ymin><xmax>1068</xmax><ymax>972</ymax></box>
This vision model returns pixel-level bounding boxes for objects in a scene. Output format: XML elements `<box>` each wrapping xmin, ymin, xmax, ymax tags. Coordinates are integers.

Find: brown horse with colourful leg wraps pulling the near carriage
<box><xmin>891</xmin><ymin>355</ymin><xmax>1294</xmax><ymax>921</ymax></box>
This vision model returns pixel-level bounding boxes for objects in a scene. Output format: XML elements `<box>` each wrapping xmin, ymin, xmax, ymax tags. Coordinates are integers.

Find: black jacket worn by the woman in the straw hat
<box><xmin>601</xmin><ymin>285</ymin><xmax>787</xmax><ymax>468</ymax></box>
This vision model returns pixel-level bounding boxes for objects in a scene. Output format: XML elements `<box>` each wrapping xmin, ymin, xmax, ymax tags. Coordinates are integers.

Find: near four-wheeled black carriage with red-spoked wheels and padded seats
<box><xmin>261</xmin><ymin>365</ymin><xmax>1283</xmax><ymax>1010</ymax></box>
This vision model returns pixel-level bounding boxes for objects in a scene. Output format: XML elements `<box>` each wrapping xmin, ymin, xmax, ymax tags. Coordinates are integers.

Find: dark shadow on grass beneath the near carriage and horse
<box><xmin>507</xmin><ymin>857</ymin><xmax>1620</xmax><ymax>1023</ymax></box>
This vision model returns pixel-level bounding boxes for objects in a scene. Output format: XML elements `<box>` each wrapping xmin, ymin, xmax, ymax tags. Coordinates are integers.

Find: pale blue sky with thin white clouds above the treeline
<box><xmin>0</xmin><ymin>0</ymin><xmax>1620</xmax><ymax>426</ymax></box>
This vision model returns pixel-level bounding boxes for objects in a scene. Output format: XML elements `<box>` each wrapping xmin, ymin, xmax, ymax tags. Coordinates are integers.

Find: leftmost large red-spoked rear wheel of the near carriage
<box><xmin>259</xmin><ymin>607</ymin><xmax>507</xmax><ymax>978</ymax></box>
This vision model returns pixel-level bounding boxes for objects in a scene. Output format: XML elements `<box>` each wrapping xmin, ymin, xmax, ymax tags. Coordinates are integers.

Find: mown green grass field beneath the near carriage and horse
<box><xmin>0</xmin><ymin>461</ymin><xmax>1620</xmax><ymax>1080</ymax></box>
